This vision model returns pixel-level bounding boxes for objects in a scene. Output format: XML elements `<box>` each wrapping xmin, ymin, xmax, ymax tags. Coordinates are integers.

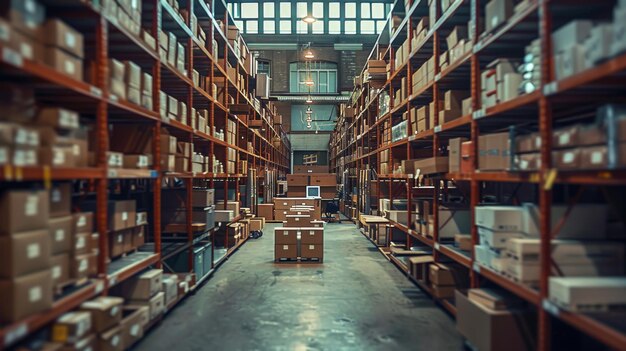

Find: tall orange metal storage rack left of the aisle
<box><xmin>0</xmin><ymin>0</ymin><xmax>291</xmax><ymax>348</ymax></box>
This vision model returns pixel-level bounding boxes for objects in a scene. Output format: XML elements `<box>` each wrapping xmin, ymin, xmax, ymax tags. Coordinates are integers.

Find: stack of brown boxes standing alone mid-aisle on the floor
<box><xmin>274</xmin><ymin>199</ymin><xmax>324</xmax><ymax>262</ymax></box>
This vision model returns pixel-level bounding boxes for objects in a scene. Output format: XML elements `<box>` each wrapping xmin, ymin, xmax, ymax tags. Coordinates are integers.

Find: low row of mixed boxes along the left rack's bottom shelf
<box><xmin>48</xmin><ymin>269</ymin><xmax>189</xmax><ymax>350</ymax></box>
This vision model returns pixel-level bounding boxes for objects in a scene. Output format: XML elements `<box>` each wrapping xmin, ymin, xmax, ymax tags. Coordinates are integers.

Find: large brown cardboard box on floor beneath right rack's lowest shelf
<box><xmin>455</xmin><ymin>290</ymin><xmax>532</xmax><ymax>351</ymax></box>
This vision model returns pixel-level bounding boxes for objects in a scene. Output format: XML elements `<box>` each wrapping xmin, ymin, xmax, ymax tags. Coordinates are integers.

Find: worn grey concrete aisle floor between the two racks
<box><xmin>136</xmin><ymin>224</ymin><xmax>463</xmax><ymax>351</ymax></box>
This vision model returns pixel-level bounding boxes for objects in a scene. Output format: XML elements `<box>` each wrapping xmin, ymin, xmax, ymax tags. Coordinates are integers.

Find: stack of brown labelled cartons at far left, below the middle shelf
<box><xmin>0</xmin><ymin>188</ymin><xmax>99</xmax><ymax>323</ymax></box>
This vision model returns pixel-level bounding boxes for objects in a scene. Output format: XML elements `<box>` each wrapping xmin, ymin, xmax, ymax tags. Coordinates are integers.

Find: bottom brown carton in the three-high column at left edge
<box><xmin>0</xmin><ymin>270</ymin><xmax>52</xmax><ymax>323</ymax></box>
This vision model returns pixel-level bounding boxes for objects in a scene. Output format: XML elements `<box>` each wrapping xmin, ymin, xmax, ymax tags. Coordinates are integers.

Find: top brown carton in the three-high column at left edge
<box><xmin>0</xmin><ymin>190</ymin><xmax>50</xmax><ymax>236</ymax></box>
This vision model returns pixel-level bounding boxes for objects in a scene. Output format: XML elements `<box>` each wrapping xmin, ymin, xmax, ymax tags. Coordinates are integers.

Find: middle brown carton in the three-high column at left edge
<box><xmin>0</xmin><ymin>229</ymin><xmax>50</xmax><ymax>278</ymax></box>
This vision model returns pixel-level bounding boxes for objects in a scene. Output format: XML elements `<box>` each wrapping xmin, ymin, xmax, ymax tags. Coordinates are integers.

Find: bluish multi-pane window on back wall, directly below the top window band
<box><xmin>289</xmin><ymin>62</ymin><xmax>337</xmax><ymax>94</ymax></box>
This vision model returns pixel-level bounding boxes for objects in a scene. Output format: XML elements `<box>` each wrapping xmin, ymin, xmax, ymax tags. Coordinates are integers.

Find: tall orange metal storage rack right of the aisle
<box><xmin>330</xmin><ymin>0</ymin><xmax>626</xmax><ymax>350</ymax></box>
